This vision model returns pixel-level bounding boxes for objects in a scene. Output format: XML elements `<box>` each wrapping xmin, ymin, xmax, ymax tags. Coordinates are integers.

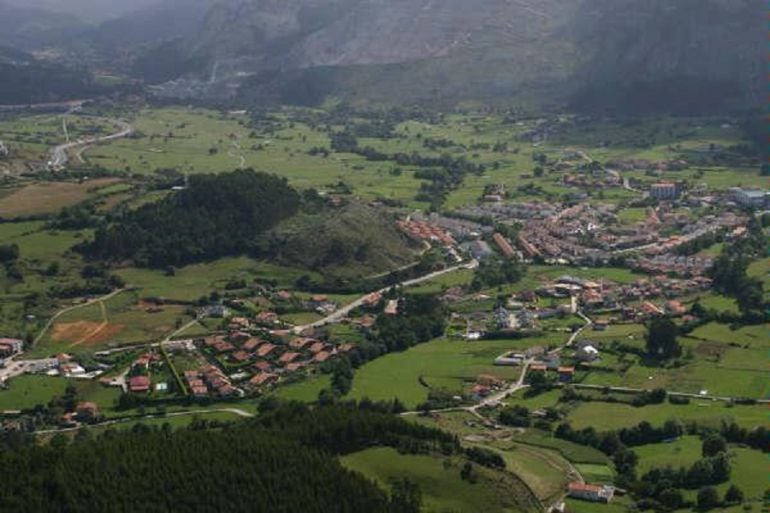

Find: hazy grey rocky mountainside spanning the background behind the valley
<box><xmin>0</xmin><ymin>0</ymin><xmax>765</xmax><ymax>112</ymax></box>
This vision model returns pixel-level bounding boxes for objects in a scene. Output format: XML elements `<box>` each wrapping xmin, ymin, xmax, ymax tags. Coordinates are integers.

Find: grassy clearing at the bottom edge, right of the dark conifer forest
<box><xmin>340</xmin><ymin>448</ymin><xmax>520</xmax><ymax>513</ymax></box>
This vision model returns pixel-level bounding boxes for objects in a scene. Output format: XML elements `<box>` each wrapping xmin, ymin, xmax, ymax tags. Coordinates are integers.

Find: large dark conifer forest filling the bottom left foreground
<box><xmin>0</xmin><ymin>403</ymin><xmax>452</xmax><ymax>513</ymax></box>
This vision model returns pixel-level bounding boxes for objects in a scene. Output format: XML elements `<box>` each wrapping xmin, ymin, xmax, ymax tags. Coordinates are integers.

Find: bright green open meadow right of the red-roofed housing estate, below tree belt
<box><xmin>349</xmin><ymin>334</ymin><xmax>564</xmax><ymax>408</ymax></box>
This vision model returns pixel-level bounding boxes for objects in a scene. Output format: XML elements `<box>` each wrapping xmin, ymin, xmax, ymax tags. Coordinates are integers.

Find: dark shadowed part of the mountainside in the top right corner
<box><xmin>573</xmin><ymin>0</ymin><xmax>767</xmax><ymax>113</ymax></box>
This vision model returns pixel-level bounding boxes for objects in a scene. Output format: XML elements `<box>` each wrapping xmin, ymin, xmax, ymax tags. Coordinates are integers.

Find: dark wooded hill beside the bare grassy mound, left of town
<box><xmin>78</xmin><ymin>170</ymin><xmax>300</xmax><ymax>268</ymax></box>
